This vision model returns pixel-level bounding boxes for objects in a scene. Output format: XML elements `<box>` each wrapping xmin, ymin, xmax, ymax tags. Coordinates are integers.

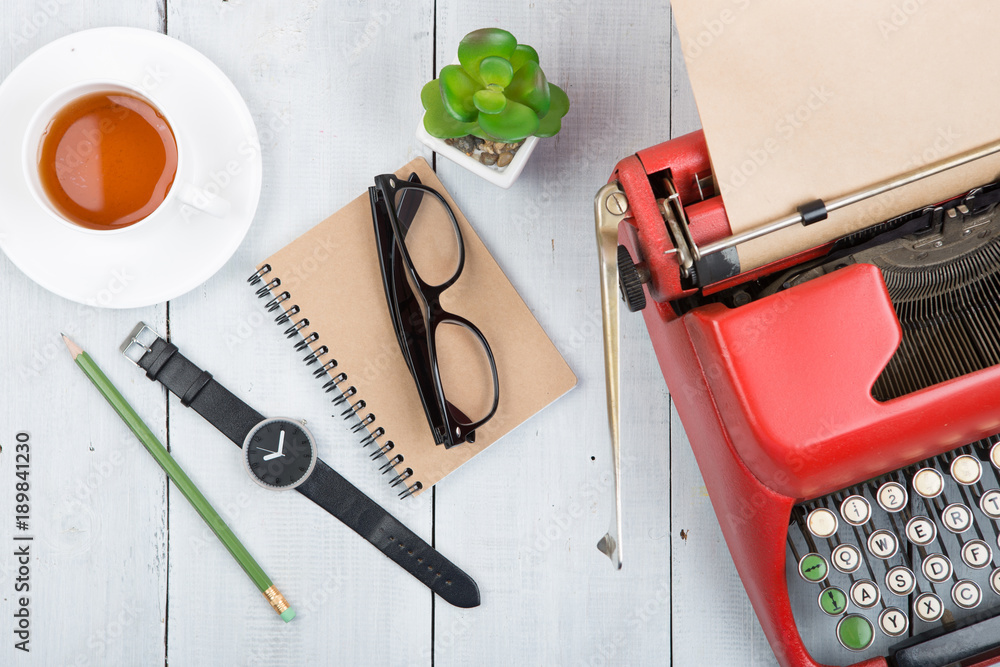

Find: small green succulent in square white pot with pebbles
<box><xmin>419</xmin><ymin>28</ymin><xmax>569</xmax><ymax>187</ymax></box>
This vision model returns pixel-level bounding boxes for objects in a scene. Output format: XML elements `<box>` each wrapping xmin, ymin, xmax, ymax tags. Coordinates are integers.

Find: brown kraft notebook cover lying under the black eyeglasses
<box><xmin>250</xmin><ymin>158</ymin><xmax>576</xmax><ymax>497</ymax></box>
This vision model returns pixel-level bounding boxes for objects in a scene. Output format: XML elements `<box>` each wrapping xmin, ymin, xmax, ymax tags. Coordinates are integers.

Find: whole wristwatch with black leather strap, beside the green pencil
<box><xmin>121</xmin><ymin>322</ymin><xmax>479</xmax><ymax>607</ymax></box>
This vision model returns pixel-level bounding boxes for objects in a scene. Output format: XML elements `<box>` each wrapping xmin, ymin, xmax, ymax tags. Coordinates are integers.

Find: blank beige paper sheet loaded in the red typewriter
<box><xmin>672</xmin><ymin>0</ymin><xmax>1000</xmax><ymax>271</ymax></box>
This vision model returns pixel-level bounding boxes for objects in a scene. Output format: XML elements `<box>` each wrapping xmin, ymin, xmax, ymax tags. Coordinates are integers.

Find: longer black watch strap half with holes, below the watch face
<box><xmin>296</xmin><ymin>461</ymin><xmax>480</xmax><ymax>607</ymax></box>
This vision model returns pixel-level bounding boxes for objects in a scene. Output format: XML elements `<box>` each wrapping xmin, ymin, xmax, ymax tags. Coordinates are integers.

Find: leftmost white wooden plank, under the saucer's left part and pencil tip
<box><xmin>0</xmin><ymin>0</ymin><xmax>167</xmax><ymax>665</ymax></box>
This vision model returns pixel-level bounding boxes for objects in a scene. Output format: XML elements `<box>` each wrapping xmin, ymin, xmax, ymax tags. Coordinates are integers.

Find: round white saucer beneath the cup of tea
<box><xmin>0</xmin><ymin>28</ymin><xmax>262</xmax><ymax>308</ymax></box>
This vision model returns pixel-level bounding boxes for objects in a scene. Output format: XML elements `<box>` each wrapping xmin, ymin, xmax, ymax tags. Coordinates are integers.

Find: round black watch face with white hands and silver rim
<box><xmin>243</xmin><ymin>418</ymin><xmax>316</xmax><ymax>489</ymax></box>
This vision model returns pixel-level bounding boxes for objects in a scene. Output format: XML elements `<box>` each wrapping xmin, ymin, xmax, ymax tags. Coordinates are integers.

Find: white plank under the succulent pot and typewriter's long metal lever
<box><xmin>434</xmin><ymin>1</ymin><xmax>671</xmax><ymax>665</ymax></box>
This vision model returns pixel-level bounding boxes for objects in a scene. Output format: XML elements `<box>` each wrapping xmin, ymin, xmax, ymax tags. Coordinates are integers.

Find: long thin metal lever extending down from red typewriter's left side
<box><xmin>594</xmin><ymin>182</ymin><xmax>628</xmax><ymax>570</ymax></box>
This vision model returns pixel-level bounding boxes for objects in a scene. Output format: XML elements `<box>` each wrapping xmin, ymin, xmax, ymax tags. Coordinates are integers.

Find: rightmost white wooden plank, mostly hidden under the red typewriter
<box><xmin>670</xmin><ymin>19</ymin><xmax>775</xmax><ymax>665</ymax></box>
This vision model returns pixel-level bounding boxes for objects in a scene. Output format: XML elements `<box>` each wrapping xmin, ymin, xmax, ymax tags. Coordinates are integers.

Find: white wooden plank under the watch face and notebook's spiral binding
<box><xmin>160</xmin><ymin>0</ymin><xmax>433</xmax><ymax>666</ymax></box>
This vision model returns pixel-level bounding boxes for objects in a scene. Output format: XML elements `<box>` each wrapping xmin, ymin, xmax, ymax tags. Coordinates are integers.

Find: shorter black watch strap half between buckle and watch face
<box><xmin>138</xmin><ymin>337</ymin><xmax>264</xmax><ymax>447</ymax></box>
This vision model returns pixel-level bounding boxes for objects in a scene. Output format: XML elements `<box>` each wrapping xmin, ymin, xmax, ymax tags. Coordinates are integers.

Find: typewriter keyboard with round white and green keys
<box><xmin>787</xmin><ymin>436</ymin><xmax>1000</xmax><ymax>665</ymax></box>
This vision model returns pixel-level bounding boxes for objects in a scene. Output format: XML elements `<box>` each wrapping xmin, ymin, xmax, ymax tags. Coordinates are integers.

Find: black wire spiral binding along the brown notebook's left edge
<box><xmin>247</xmin><ymin>264</ymin><xmax>423</xmax><ymax>499</ymax></box>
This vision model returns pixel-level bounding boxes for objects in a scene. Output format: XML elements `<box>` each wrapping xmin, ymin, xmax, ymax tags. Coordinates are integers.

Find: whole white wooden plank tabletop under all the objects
<box><xmin>0</xmin><ymin>0</ymin><xmax>773</xmax><ymax>667</ymax></box>
